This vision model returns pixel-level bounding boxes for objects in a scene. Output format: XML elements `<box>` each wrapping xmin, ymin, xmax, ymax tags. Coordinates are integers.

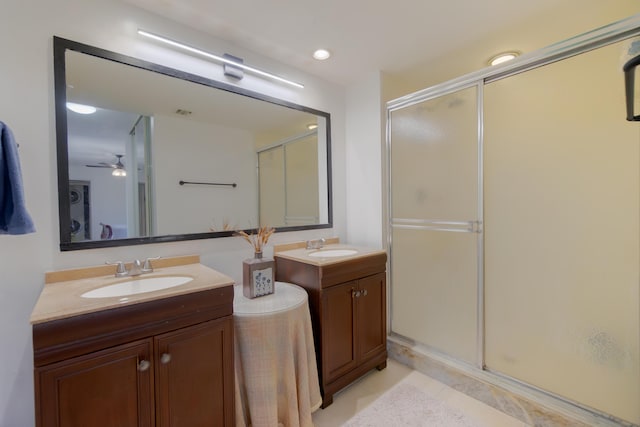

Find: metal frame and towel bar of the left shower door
<box><xmin>385</xmin><ymin>81</ymin><xmax>485</xmax><ymax>369</ymax></box>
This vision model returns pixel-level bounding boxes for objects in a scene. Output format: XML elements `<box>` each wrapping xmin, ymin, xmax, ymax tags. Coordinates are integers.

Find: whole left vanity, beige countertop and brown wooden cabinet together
<box><xmin>31</xmin><ymin>256</ymin><xmax>234</xmax><ymax>427</ymax></box>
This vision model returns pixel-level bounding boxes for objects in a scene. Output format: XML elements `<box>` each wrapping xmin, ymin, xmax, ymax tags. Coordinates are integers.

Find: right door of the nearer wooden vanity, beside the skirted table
<box><xmin>155</xmin><ymin>316</ymin><xmax>234</xmax><ymax>427</ymax></box>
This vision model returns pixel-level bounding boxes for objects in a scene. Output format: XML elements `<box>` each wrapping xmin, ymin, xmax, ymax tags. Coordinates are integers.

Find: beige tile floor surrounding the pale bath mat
<box><xmin>313</xmin><ymin>359</ymin><xmax>527</xmax><ymax>427</ymax></box>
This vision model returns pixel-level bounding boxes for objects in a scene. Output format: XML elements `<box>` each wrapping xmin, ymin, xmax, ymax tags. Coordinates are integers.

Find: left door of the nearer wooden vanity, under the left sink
<box><xmin>35</xmin><ymin>339</ymin><xmax>154</xmax><ymax>427</ymax></box>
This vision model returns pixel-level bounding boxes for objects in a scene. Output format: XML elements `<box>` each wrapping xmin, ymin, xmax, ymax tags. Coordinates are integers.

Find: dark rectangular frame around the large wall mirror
<box><xmin>53</xmin><ymin>36</ymin><xmax>333</xmax><ymax>251</ymax></box>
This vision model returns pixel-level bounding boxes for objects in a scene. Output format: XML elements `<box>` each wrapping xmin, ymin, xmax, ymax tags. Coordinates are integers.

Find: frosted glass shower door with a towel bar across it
<box><xmin>389</xmin><ymin>86</ymin><xmax>481</xmax><ymax>363</ymax></box>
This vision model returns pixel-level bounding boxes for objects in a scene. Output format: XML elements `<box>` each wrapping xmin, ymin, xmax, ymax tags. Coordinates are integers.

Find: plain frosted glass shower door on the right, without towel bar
<box><xmin>484</xmin><ymin>43</ymin><xmax>640</xmax><ymax>424</ymax></box>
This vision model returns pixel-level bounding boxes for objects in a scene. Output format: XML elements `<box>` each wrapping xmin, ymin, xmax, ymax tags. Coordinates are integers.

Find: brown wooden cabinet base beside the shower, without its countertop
<box><xmin>275</xmin><ymin>253</ymin><xmax>387</xmax><ymax>408</ymax></box>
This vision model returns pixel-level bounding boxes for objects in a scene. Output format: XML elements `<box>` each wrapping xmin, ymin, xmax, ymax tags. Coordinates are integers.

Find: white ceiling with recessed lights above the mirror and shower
<box><xmin>125</xmin><ymin>0</ymin><xmax>640</xmax><ymax>85</ymax></box>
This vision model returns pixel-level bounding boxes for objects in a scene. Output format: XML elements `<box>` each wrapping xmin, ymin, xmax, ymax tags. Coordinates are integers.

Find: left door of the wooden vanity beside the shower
<box><xmin>321</xmin><ymin>281</ymin><xmax>357</xmax><ymax>384</ymax></box>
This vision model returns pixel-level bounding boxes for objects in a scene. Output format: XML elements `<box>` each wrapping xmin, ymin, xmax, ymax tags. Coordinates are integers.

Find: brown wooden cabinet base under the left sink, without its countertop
<box><xmin>33</xmin><ymin>286</ymin><xmax>235</xmax><ymax>427</ymax></box>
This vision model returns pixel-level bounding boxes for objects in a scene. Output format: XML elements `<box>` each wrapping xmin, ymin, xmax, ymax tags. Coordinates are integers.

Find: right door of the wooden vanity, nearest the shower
<box><xmin>356</xmin><ymin>273</ymin><xmax>387</xmax><ymax>362</ymax></box>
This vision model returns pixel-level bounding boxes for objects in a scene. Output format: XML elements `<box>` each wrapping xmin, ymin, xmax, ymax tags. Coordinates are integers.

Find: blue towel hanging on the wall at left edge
<box><xmin>0</xmin><ymin>122</ymin><xmax>36</xmax><ymax>234</ymax></box>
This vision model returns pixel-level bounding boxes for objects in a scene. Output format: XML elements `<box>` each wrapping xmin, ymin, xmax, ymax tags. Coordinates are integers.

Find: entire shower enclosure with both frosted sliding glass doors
<box><xmin>386</xmin><ymin>18</ymin><xmax>640</xmax><ymax>424</ymax></box>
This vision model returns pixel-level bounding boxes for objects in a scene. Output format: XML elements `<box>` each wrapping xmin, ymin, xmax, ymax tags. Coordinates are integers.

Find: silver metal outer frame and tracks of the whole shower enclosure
<box><xmin>383</xmin><ymin>14</ymin><xmax>640</xmax><ymax>423</ymax></box>
